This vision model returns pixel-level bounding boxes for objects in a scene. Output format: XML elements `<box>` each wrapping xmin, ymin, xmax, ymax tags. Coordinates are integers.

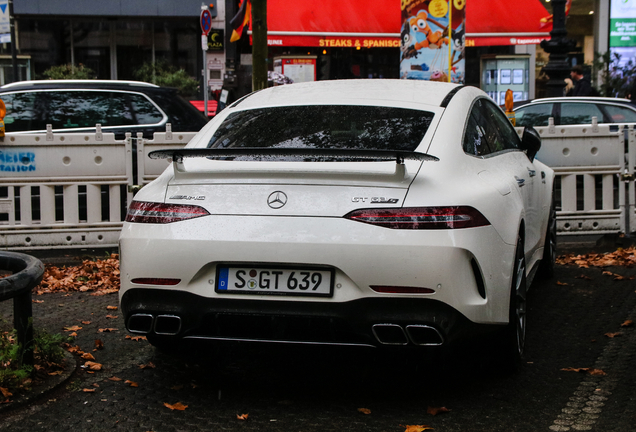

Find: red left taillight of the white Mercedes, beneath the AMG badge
<box><xmin>126</xmin><ymin>201</ymin><xmax>210</xmax><ymax>224</ymax></box>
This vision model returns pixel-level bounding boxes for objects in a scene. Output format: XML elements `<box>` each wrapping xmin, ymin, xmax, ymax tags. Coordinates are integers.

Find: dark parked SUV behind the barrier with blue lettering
<box><xmin>0</xmin><ymin>80</ymin><xmax>208</xmax><ymax>139</ymax></box>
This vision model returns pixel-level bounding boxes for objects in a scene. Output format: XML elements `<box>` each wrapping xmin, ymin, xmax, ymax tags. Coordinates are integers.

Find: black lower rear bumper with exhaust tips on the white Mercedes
<box><xmin>121</xmin><ymin>289</ymin><xmax>498</xmax><ymax>346</ymax></box>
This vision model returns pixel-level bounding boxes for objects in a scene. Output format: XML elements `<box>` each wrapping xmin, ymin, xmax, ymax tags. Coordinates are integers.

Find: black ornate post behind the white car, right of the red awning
<box><xmin>541</xmin><ymin>0</ymin><xmax>576</xmax><ymax>97</ymax></box>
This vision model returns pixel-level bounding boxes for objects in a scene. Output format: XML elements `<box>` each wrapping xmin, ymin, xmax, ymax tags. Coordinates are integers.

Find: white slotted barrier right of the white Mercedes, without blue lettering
<box><xmin>536</xmin><ymin>119</ymin><xmax>636</xmax><ymax>235</ymax></box>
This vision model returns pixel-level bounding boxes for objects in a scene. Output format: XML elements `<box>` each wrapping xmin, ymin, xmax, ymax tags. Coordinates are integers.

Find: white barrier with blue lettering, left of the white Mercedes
<box><xmin>0</xmin><ymin>129</ymin><xmax>194</xmax><ymax>250</ymax></box>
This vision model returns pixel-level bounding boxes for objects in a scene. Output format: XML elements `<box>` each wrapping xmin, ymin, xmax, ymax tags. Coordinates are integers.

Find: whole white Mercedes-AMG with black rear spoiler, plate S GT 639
<box><xmin>120</xmin><ymin>79</ymin><xmax>556</xmax><ymax>360</ymax></box>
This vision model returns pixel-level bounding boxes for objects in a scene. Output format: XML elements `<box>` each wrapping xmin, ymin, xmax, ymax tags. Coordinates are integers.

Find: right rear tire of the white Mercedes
<box><xmin>498</xmin><ymin>236</ymin><xmax>528</xmax><ymax>370</ymax></box>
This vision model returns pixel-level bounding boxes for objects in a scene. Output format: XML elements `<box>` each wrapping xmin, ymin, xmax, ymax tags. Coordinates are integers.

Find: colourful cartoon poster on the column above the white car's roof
<box><xmin>400</xmin><ymin>0</ymin><xmax>466</xmax><ymax>83</ymax></box>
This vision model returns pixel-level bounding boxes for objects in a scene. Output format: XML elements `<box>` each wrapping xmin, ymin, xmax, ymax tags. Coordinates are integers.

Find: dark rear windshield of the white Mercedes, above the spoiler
<box><xmin>208</xmin><ymin>105</ymin><xmax>434</xmax><ymax>151</ymax></box>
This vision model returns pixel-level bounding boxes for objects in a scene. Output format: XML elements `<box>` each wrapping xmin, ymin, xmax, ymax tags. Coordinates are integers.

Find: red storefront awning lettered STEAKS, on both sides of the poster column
<box><xmin>258</xmin><ymin>0</ymin><xmax>552</xmax><ymax>48</ymax></box>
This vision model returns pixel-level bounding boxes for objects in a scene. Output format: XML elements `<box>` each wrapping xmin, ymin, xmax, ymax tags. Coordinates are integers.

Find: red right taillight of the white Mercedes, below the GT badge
<box><xmin>345</xmin><ymin>206</ymin><xmax>490</xmax><ymax>229</ymax></box>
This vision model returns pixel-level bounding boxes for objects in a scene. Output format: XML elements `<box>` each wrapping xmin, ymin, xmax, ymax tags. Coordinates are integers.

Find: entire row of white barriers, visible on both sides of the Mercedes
<box><xmin>0</xmin><ymin>123</ymin><xmax>636</xmax><ymax>250</ymax></box>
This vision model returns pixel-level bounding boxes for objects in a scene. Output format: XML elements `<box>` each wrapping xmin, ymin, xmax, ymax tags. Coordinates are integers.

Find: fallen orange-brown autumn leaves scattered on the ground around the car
<box><xmin>0</xmin><ymin>247</ymin><xmax>636</xmax><ymax>432</ymax></box>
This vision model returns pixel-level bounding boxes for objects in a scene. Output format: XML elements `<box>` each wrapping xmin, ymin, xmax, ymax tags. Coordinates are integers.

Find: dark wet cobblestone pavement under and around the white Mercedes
<box><xmin>0</xmin><ymin>243</ymin><xmax>636</xmax><ymax>432</ymax></box>
